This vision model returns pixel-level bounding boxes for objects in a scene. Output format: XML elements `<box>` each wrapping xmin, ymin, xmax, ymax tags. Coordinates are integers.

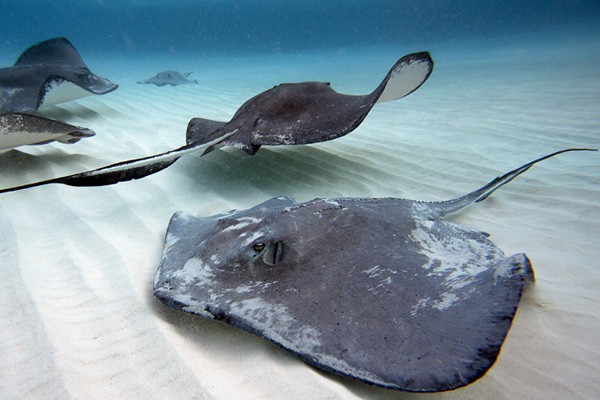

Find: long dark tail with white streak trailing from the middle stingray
<box><xmin>0</xmin><ymin>132</ymin><xmax>235</xmax><ymax>194</ymax></box>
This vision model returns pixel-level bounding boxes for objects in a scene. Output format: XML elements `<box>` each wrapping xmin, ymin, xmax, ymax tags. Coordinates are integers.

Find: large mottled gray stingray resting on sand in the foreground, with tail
<box><xmin>154</xmin><ymin>149</ymin><xmax>591</xmax><ymax>392</ymax></box>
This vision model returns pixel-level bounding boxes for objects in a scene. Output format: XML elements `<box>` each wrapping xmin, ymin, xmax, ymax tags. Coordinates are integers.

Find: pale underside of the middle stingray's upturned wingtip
<box><xmin>373</xmin><ymin>51</ymin><xmax>433</xmax><ymax>103</ymax></box>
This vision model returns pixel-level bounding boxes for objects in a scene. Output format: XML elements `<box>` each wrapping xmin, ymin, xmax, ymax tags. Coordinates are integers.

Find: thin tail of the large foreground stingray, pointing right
<box><xmin>429</xmin><ymin>148</ymin><xmax>598</xmax><ymax>218</ymax></box>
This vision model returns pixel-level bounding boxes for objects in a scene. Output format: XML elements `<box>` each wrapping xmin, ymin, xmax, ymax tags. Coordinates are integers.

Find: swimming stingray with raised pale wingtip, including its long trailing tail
<box><xmin>0</xmin><ymin>52</ymin><xmax>433</xmax><ymax>193</ymax></box>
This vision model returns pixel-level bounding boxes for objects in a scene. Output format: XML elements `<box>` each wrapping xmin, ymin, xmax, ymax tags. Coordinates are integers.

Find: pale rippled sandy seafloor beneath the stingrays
<box><xmin>0</xmin><ymin>29</ymin><xmax>600</xmax><ymax>400</ymax></box>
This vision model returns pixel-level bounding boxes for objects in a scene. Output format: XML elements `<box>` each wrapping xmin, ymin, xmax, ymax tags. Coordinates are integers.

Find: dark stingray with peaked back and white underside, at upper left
<box><xmin>0</xmin><ymin>38</ymin><xmax>118</xmax><ymax>112</ymax></box>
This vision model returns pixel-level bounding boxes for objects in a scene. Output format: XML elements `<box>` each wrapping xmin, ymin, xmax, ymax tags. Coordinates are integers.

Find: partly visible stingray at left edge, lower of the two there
<box><xmin>0</xmin><ymin>113</ymin><xmax>95</xmax><ymax>149</ymax></box>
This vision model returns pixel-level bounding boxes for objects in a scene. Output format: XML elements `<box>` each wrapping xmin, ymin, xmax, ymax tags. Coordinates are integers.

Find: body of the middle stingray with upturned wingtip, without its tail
<box><xmin>186</xmin><ymin>52</ymin><xmax>433</xmax><ymax>155</ymax></box>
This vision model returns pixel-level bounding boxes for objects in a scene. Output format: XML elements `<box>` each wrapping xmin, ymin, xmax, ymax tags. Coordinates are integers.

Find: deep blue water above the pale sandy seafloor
<box><xmin>0</xmin><ymin>0</ymin><xmax>600</xmax><ymax>59</ymax></box>
